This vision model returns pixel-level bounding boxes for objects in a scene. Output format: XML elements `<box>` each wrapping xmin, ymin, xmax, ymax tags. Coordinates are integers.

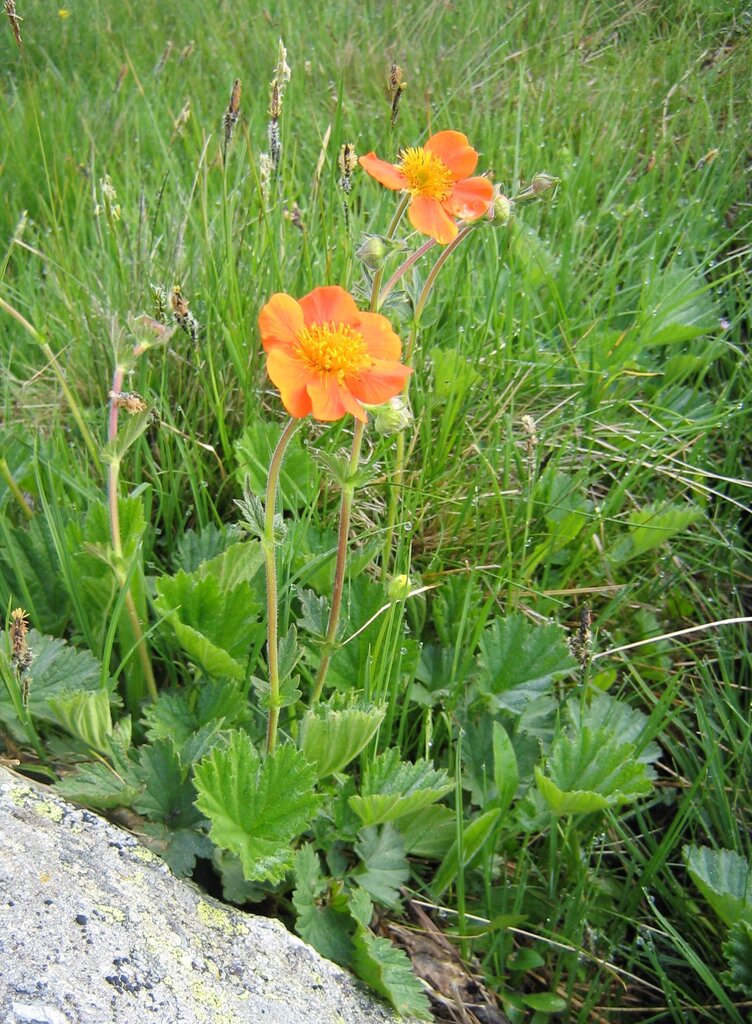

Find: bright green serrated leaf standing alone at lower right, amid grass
<box><xmin>535</xmin><ymin>727</ymin><xmax>653</xmax><ymax>815</ymax></box>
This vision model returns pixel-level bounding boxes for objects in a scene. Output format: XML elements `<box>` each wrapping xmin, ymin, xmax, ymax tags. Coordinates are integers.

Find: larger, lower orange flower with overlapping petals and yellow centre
<box><xmin>258</xmin><ymin>285</ymin><xmax>412</xmax><ymax>423</ymax></box>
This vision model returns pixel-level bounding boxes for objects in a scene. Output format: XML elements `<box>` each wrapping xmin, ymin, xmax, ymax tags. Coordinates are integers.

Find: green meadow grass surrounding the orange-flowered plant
<box><xmin>0</xmin><ymin>0</ymin><xmax>752</xmax><ymax>1024</ymax></box>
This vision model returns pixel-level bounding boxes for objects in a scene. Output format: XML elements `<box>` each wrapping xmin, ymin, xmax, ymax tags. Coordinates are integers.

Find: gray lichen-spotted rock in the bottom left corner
<box><xmin>0</xmin><ymin>767</ymin><xmax>418</xmax><ymax>1024</ymax></box>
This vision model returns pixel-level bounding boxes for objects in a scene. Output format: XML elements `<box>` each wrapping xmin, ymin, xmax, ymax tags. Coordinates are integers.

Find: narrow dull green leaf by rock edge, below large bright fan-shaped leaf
<box><xmin>292</xmin><ymin>844</ymin><xmax>353</xmax><ymax>967</ymax></box>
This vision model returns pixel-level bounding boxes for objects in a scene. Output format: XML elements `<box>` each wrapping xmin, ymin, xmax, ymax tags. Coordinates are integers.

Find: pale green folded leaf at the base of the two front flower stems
<box><xmin>300</xmin><ymin>706</ymin><xmax>384</xmax><ymax>778</ymax></box>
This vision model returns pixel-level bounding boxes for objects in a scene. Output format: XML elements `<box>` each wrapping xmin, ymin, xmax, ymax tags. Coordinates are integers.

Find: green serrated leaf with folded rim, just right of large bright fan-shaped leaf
<box><xmin>348</xmin><ymin>750</ymin><xmax>454</xmax><ymax>825</ymax></box>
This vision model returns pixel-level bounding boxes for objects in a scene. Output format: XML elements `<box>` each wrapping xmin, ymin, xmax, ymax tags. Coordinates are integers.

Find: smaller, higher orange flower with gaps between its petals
<box><xmin>360</xmin><ymin>131</ymin><xmax>494</xmax><ymax>245</ymax></box>
